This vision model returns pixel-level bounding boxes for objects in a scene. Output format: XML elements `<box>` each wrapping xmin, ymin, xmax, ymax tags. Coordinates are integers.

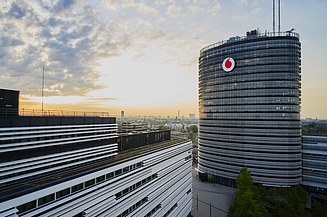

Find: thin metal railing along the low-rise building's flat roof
<box><xmin>0</xmin><ymin>108</ymin><xmax>109</xmax><ymax>117</ymax></box>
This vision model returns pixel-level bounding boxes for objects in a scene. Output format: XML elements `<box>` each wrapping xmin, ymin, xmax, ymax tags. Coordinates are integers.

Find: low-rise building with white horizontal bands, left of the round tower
<box><xmin>0</xmin><ymin>113</ymin><xmax>192</xmax><ymax>217</ymax></box>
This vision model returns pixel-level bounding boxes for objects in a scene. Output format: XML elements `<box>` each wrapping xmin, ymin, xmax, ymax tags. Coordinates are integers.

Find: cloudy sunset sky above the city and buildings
<box><xmin>0</xmin><ymin>0</ymin><xmax>327</xmax><ymax>119</ymax></box>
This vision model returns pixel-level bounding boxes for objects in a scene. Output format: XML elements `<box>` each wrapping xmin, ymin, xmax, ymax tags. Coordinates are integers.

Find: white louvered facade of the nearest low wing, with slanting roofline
<box><xmin>0</xmin><ymin>142</ymin><xmax>192</xmax><ymax>217</ymax></box>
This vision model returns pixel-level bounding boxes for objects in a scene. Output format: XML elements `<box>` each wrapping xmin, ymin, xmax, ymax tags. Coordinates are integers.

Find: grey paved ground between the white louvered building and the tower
<box><xmin>192</xmin><ymin>168</ymin><xmax>235</xmax><ymax>217</ymax></box>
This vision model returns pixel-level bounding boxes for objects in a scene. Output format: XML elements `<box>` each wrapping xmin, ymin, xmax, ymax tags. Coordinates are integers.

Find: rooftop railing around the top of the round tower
<box><xmin>200</xmin><ymin>31</ymin><xmax>300</xmax><ymax>55</ymax></box>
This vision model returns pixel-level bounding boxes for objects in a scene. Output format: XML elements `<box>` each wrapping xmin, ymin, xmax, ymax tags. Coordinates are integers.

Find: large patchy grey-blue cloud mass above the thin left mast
<box><xmin>0</xmin><ymin>0</ymin><xmax>129</xmax><ymax>95</ymax></box>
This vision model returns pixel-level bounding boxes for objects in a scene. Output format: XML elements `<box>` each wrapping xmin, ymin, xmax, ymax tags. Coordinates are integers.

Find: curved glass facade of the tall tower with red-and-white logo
<box><xmin>199</xmin><ymin>33</ymin><xmax>301</xmax><ymax>186</ymax></box>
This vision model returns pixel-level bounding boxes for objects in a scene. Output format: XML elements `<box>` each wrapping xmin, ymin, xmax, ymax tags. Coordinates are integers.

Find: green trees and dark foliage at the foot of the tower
<box><xmin>228</xmin><ymin>167</ymin><xmax>327</xmax><ymax>217</ymax></box>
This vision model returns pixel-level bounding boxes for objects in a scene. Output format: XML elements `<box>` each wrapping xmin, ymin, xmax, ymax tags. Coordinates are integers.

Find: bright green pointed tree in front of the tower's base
<box><xmin>228</xmin><ymin>167</ymin><xmax>271</xmax><ymax>217</ymax></box>
